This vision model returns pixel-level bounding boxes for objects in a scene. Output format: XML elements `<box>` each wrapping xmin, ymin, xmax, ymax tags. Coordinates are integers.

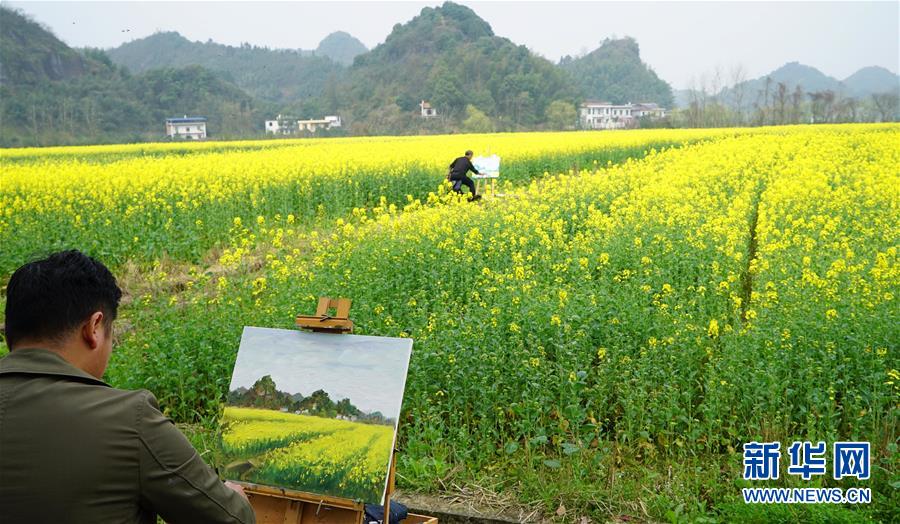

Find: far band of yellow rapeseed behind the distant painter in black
<box><xmin>0</xmin><ymin>130</ymin><xmax>733</xmax><ymax>273</ymax></box>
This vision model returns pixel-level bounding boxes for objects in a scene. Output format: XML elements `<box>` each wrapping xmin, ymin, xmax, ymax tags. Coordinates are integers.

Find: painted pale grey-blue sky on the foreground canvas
<box><xmin>228</xmin><ymin>327</ymin><xmax>412</xmax><ymax>420</ymax></box>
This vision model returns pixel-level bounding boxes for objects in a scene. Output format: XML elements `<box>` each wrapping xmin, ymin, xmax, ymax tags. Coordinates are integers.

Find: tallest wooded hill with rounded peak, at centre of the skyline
<box><xmin>332</xmin><ymin>2</ymin><xmax>577</xmax><ymax>134</ymax></box>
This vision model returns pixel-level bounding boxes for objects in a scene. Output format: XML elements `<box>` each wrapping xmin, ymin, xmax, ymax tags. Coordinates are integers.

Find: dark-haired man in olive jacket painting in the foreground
<box><xmin>0</xmin><ymin>251</ymin><xmax>256</xmax><ymax>524</ymax></box>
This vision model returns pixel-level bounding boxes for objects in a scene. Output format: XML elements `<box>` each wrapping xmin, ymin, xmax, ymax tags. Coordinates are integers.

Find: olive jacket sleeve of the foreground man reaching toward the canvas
<box><xmin>138</xmin><ymin>392</ymin><xmax>256</xmax><ymax>524</ymax></box>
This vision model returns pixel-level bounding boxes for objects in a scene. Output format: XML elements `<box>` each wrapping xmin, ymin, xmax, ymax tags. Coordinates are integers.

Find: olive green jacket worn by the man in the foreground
<box><xmin>0</xmin><ymin>349</ymin><xmax>256</xmax><ymax>523</ymax></box>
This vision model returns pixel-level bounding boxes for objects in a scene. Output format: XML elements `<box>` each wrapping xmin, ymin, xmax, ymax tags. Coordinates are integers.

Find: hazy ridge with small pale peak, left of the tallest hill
<box><xmin>107</xmin><ymin>32</ymin><xmax>344</xmax><ymax>104</ymax></box>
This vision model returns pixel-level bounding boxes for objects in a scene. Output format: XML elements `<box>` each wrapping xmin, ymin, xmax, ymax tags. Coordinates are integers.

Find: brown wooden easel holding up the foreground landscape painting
<box><xmin>238</xmin><ymin>297</ymin><xmax>438</xmax><ymax>524</ymax></box>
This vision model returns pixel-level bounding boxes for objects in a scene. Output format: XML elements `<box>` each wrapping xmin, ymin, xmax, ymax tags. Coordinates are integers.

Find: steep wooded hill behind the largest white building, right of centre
<box><xmin>559</xmin><ymin>38</ymin><xmax>673</xmax><ymax>107</ymax></box>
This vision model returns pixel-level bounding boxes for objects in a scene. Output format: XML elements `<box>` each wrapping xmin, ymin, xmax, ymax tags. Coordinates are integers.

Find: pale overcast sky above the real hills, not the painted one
<box><xmin>3</xmin><ymin>0</ymin><xmax>900</xmax><ymax>88</ymax></box>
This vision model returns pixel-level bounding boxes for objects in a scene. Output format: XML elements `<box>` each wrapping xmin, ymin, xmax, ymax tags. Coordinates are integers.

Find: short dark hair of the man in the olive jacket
<box><xmin>5</xmin><ymin>250</ymin><xmax>122</xmax><ymax>348</ymax></box>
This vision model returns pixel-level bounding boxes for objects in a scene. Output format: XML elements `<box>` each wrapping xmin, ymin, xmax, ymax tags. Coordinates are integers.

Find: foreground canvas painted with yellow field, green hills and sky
<box><xmin>221</xmin><ymin>327</ymin><xmax>412</xmax><ymax>504</ymax></box>
